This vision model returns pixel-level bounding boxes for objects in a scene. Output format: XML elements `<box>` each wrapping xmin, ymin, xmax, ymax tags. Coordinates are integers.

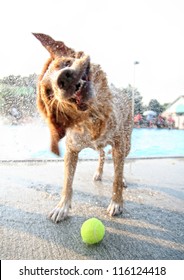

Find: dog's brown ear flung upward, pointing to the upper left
<box><xmin>33</xmin><ymin>33</ymin><xmax>75</xmax><ymax>58</ymax></box>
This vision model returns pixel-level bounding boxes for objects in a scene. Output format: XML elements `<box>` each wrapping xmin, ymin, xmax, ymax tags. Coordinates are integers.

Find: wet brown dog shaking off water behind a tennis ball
<box><xmin>34</xmin><ymin>34</ymin><xmax>132</xmax><ymax>222</ymax></box>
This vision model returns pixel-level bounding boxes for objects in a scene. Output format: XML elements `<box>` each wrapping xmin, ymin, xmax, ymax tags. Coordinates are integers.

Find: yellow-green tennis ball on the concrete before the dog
<box><xmin>81</xmin><ymin>218</ymin><xmax>105</xmax><ymax>244</ymax></box>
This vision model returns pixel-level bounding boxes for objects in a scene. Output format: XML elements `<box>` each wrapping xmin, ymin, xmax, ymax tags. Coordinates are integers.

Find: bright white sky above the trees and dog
<box><xmin>0</xmin><ymin>0</ymin><xmax>184</xmax><ymax>104</ymax></box>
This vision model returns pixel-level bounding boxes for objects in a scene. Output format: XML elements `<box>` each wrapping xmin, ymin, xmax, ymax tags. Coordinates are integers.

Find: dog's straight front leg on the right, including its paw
<box><xmin>107</xmin><ymin>145</ymin><xmax>124</xmax><ymax>216</ymax></box>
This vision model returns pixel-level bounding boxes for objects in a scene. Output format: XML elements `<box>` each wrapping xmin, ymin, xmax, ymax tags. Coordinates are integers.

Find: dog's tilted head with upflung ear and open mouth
<box><xmin>33</xmin><ymin>33</ymin><xmax>93</xmax><ymax>111</ymax></box>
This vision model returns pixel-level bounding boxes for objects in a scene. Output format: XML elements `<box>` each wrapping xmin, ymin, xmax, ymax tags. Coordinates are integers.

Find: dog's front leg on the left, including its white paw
<box><xmin>50</xmin><ymin>149</ymin><xmax>78</xmax><ymax>223</ymax></box>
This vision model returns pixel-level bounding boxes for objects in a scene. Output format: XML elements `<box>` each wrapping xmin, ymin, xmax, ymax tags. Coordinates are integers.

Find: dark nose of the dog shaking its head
<box><xmin>57</xmin><ymin>69</ymin><xmax>76</xmax><ymax>90</ymax></box>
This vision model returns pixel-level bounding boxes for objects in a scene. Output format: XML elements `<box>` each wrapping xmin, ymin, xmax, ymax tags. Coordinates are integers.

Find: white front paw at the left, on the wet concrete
<box><xmin>49</xmin><ymin>202</ymin><xmax>71</xmax><ymax>223</ymax></box>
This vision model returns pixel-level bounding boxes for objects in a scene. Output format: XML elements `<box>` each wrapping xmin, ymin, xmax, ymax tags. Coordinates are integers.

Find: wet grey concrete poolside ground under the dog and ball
<box><xmin>0</xmin><ymin>158</ymin><xmax>184</xmax><ymax>260</ymax></box>
